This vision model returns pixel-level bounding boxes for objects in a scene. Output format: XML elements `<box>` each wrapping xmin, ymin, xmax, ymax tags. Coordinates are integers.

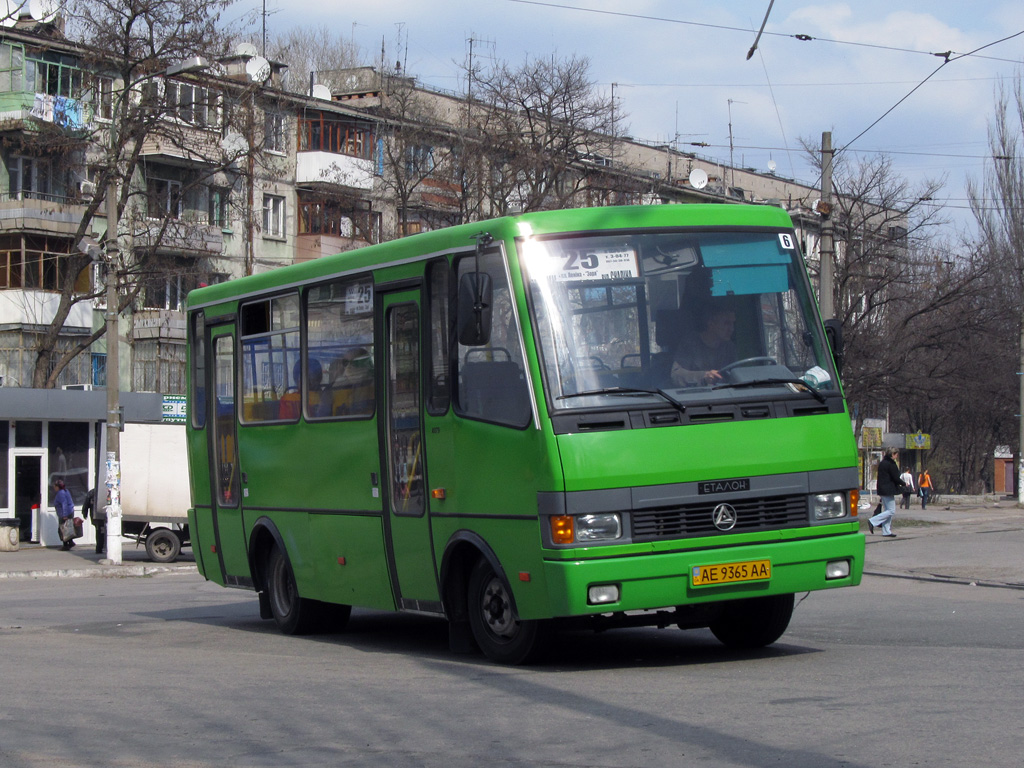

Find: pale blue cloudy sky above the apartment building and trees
<box><xmin>225</xmin><ymin>0</ymin><xmax>1024</xmax><ymax>239</ymax></box>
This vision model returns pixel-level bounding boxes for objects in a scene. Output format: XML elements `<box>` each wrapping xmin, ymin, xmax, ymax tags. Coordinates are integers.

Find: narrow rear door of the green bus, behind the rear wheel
<box><xmin>204</xmin><ymin>325</ymin><xmax>252</xmax><ymax>586</ymax></box>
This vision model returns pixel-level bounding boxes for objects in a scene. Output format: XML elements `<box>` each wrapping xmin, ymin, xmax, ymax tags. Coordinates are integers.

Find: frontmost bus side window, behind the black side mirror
<box><xmin>456</xmin><ymin>256</ymin><xmax>531</xmax><ymax>427</ymax></box>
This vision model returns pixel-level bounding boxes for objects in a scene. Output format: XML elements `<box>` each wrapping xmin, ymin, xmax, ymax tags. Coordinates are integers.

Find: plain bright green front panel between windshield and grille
<box><xmin>558</xmin><ymin>414</ymin><xmax>856</xmax><ymax>490</ymax></box>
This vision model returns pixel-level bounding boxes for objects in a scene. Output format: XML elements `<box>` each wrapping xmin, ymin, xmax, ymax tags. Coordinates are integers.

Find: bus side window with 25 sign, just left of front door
<box><xmin>306</xmin><ymin>275</ymin><xmax>377</xmax><ymax>419</ymax></box>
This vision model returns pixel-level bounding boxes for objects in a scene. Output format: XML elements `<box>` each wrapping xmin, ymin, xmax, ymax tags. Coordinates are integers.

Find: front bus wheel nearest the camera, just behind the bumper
<box><xmin>467</xmin><ymin>558</ymin><xmax>548</xmax><ymax>665</ymax></box>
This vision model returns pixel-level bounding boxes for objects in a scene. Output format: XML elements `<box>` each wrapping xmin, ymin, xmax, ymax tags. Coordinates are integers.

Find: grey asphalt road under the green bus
<box><xmin>0</xmin><ymin>572</ymin><xmax>1024</xmax><ymax>768</ymax></box>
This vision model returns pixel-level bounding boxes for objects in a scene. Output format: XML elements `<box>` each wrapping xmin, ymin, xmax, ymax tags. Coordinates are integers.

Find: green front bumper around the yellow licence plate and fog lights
<box><xmin>536</xmin><ymin>534</ymin><xmax>864</xmax><ymax>618</ymax></box>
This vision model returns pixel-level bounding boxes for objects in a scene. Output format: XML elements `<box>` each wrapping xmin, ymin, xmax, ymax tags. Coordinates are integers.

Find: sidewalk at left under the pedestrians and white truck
<box><xmin>0</xmin><ymin>540</ymin><xmax>196</xmax><ymax>581</ymax></box>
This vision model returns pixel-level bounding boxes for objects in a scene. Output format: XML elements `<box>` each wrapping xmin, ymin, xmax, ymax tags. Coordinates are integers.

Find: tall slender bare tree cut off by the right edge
<box><xmin>968</xmin><ymin>76</ymin><xmax>1024</xmax><ymax>504</ymax></box>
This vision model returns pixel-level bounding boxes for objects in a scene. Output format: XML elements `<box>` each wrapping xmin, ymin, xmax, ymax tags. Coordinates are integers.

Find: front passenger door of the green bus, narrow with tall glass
<box><xmin>378</xmin><ymin>289</ymin><xmax>440</xmax><ymax>611</ymax></box>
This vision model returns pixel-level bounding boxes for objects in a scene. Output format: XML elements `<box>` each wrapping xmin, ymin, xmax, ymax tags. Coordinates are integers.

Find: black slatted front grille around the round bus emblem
<box><xmin>632</xmin><ymin>496</ymin><xmax>808</xmax><ymax>542</ymax></box>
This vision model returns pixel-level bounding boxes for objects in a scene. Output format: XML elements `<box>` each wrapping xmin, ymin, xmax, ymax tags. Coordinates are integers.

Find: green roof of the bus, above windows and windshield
<box><xmin>187</xmin><ymin>204</ymin><xmax>793</xmax><ymax>308</ymax></box>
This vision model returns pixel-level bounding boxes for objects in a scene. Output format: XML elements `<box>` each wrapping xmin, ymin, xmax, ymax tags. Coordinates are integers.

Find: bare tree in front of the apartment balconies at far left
<box><xmin>26</xmin><ymin>0</ymin><xmax>233</xmax><ymax>387</ymax></box>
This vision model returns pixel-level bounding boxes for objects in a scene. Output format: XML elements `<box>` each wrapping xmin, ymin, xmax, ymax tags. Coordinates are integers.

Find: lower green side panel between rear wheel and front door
<box><xmin>299</xmin><ymin>515</ymin><xmax>395</xmax><ymax>610</ymax></box>
